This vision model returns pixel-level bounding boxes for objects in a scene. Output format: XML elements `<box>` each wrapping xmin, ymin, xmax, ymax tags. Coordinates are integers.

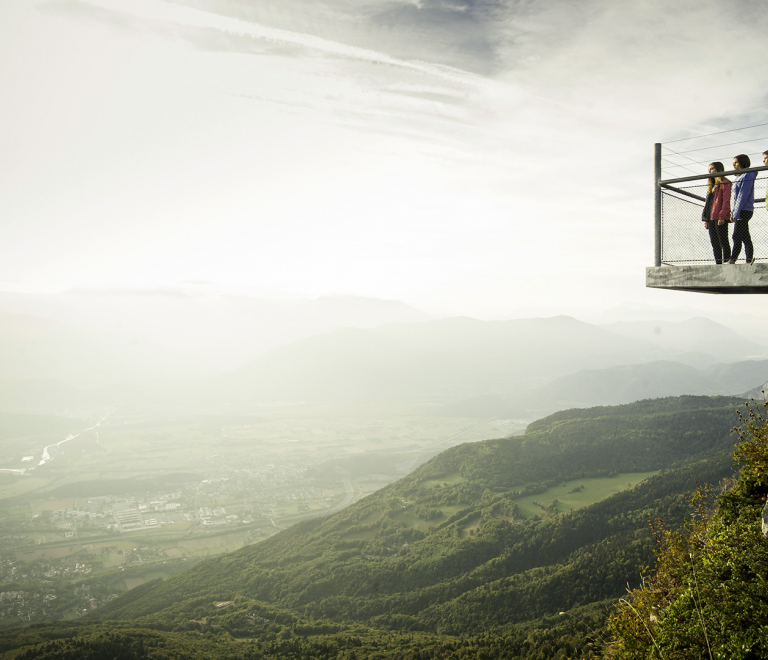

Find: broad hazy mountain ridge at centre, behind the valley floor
<box><xmin>224</xmin><ymin>317</ymin><xmax>659</xmax><ymax>400</ymax></box>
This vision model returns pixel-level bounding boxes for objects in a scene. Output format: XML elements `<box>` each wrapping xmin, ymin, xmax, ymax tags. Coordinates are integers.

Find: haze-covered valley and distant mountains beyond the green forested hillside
<box><xmin>0</xmin><ymin>292</ymin><xmax>768</xmax><ymax>640</ymax></box>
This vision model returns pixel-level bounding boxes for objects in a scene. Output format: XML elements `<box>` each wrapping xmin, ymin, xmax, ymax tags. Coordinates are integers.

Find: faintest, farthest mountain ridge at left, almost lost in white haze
<box><xmin>0</xmin><ymin>286</ymin><xmax>430</xmax><ymax>372</ymax></box>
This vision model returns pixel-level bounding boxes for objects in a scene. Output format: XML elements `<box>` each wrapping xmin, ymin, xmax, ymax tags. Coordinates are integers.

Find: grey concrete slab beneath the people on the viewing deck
<box><xmin>645</xmin><ymin>263</ymin><xmax>768</xmax><ymax>293</ymax></box>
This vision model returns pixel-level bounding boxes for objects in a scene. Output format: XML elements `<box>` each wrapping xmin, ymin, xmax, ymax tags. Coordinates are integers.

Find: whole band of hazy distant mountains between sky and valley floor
<box><xmin>0</xmin><ymin>291</ymin><xmax>768</xmax><ymax>418</ymax></box>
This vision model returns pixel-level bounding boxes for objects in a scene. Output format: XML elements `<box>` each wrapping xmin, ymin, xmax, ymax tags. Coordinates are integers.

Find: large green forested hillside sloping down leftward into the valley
<box><xmin>0</xmin><ymin>397</ymin><xmax>752</xmax><ymax>658</ymax></box>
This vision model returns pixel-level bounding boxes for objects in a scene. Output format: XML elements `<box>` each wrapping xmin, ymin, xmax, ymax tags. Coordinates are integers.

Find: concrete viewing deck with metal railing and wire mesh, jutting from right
<box><xmin>645</xmin><ymin>133</ymin><xmax>768</xmax><ymax>293</ymax></box>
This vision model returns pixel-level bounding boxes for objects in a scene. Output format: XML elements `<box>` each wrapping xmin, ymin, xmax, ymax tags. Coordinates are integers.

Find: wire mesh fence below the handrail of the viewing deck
<box><xmin>661</xmin><ymin>177</ymin><xmax>768</xmax><ymax>265</ymax></box>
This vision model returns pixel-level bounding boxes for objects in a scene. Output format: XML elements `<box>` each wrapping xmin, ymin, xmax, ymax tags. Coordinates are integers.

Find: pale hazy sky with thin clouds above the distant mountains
<box><xmin>0</xmin><ymin>0</ymin><xmax>768</xmax><ymax>317</ymax></box>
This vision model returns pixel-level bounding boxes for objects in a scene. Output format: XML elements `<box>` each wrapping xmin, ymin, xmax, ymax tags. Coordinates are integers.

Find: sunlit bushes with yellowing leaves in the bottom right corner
<box><xmin>606</xmin><ymin>404</ymin><xmax>768</xmax><ymax>660</ymax></box>
